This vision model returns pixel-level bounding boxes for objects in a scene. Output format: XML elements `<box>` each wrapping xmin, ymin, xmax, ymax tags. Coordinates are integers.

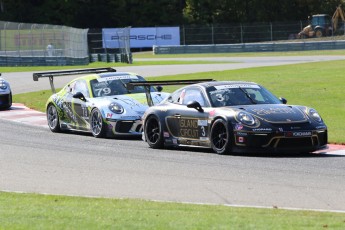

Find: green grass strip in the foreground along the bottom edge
<box><xmin>0</xmin><ymin>192</ymin><xmax>345</xmax><ymax>230</ymax></box>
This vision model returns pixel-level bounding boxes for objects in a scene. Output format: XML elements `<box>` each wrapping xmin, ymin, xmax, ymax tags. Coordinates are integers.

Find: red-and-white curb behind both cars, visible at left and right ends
<box><xmin>0</xmin><ymin>103</ymin><xmax>345</xmax><ymax>156</ymax></box>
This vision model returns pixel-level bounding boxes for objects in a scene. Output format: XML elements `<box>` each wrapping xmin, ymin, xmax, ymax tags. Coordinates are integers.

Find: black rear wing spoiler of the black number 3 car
<box><xmin>126</xmin><ymin>79</ymin><xmax>214</xmax><ymax>106</ymax></box>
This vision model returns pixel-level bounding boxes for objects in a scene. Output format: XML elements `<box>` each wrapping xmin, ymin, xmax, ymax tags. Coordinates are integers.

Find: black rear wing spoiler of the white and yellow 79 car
<box><xmin>33</xmin><ymin>67</ymin><xmax>116</xmax><ymax>93</ymax></box>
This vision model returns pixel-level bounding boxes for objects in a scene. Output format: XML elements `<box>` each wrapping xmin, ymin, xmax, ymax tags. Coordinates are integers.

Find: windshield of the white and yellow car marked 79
<box><xmin>90</xmin><ymin>75</ymin><xmax>155</xmax><ymax>97</ymax></box>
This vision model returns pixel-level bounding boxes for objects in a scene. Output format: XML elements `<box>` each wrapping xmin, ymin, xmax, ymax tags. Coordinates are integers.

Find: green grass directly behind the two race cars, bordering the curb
<box><xmin>14</xmin><ymin>58</ymin><xmax>345</xmax><ymax>143</ymax></box>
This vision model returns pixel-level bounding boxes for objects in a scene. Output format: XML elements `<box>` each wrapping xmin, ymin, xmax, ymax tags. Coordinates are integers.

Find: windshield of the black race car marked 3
<box><xmin>207</xmin><ymin>84</ymin><xmax>282</xmax><ymax>107</ymax></box>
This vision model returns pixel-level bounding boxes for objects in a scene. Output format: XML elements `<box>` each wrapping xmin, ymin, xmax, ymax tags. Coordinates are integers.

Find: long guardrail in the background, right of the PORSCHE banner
<box><xmin>153</xmin><ymin>40</ymin><xmax>345</xmax><ymax>54</ymax></box>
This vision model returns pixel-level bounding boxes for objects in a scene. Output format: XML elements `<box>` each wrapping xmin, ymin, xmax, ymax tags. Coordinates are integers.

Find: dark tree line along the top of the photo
<box><xmin>0</xmin><ymin>0</ymin><xmax>345</xmax><ymax>28</ymax></box>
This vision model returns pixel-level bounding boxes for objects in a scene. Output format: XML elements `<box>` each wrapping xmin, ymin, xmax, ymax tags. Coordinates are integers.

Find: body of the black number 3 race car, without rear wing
<box><xmin>139</xmin><ymin>81</ymin><xmax>327</xmax><ymax>154</ymax></box>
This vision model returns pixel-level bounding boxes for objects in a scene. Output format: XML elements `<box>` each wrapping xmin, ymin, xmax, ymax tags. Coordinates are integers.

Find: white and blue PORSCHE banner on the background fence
<box><xmin>102</xmin><ymin>27</ymin><xmax>180</xmax><ymax>48</ymax></box>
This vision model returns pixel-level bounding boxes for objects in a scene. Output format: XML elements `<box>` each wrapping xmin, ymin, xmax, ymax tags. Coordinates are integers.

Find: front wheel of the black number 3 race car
<box><xmin>211</xmin><ymin>119</ymin><xmax>231</xmax><ymax>155</ymax></box>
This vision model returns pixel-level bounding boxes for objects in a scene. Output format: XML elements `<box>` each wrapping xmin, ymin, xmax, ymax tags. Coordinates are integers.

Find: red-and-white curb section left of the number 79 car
<box><xmin>0</xmin><ymin>103</ymin><xmax>48</xmax><ymax>128</ymax></box>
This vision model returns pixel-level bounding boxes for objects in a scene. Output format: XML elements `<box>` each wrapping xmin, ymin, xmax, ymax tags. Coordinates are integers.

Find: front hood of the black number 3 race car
<box><xmin>239</xmin><ymin>104</ymin><xmax>308</xmax><ymax>123</ymax></box>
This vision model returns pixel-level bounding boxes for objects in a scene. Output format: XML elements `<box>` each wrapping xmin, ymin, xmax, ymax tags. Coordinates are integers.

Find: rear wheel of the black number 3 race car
<box><xmin>144</xmin><ymin>116</ymin><xmax>164</xmax><ymax>149</ymax></box>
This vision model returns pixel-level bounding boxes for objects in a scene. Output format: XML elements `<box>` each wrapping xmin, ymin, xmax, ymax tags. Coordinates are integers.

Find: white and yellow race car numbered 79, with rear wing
<box><xmin>33</xmin><ymin>68</ymin><xmax>169</xmax><ymax>137</ymax></box>
